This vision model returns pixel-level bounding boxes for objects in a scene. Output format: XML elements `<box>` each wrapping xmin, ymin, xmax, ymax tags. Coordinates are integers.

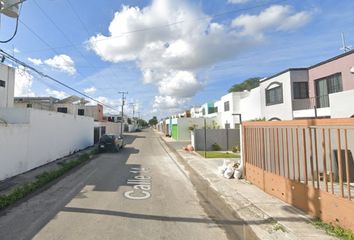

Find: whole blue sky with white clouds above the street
<box><xmin>0</xmin><ymin>0</ymin><xmax>354</xmax><ymax>119</ymax></box>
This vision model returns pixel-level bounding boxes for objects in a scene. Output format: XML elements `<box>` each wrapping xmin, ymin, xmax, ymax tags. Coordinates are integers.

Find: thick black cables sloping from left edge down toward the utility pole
<box><xmin>0</xmin><ymin>49</ymin><xmax>117</xmax><ymax>111</ymax></box>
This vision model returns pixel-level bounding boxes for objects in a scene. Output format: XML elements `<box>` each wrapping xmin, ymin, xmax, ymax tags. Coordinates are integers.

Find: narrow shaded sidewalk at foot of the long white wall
<box><xmin>0</xmin><ymin>146</ymin><xmax>95</xmax><ymax>195</ymax></box>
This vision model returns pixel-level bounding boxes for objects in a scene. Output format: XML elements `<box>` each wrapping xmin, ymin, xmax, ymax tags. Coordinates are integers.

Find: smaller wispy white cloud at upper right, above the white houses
<box><xmin>232</xmin><ymin>5</ymin><xmax>311</xmax><ymax>38</ymax></box>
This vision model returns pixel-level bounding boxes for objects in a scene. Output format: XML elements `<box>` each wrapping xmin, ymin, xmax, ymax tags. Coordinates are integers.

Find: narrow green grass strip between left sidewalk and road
<box><xmin>0</xmin><ymin>149</ymin><xmax>97</xmax><ymax>210</ymax></box>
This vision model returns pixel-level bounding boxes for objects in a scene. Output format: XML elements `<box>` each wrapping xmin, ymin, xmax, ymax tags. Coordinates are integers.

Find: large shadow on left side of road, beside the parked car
<box><xmin>0</xmin><ymin>146</ymin><xmax>141</xmax><ymax>240</ymax></box>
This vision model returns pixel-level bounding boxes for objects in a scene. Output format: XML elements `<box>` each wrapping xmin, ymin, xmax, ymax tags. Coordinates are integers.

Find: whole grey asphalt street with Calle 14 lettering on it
<box><xmin>0</xmin><ymin>130</ymin><xmax>255</xmax><ymax>240</ymax></box>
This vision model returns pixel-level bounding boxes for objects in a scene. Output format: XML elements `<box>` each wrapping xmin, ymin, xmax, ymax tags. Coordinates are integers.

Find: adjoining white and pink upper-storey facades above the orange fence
<box><xmin>260</xmin><ymin>50</ymin><xmax>354</xmax><ymax>120</ymax></box>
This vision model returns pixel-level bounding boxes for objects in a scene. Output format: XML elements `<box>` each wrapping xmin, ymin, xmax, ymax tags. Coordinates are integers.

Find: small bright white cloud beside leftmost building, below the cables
<box><xmin>15</xmin><ymin>67</ymin><xmax>35</xmax><ymax>97</ymax></box>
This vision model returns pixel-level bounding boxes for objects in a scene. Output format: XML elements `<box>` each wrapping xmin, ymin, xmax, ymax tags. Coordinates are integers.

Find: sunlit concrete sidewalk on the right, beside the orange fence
<box><xmin>161</xmin><ymin>136</ymin><xmax>337</xmax><ymax>240</ymax></box>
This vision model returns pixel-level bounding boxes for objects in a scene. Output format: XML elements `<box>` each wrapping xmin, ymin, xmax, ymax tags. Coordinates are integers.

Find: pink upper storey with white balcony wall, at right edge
<box><xmin>293</xmin><ymin>50</ymin><xmax>354</xmax><ymax>119</ymax></box>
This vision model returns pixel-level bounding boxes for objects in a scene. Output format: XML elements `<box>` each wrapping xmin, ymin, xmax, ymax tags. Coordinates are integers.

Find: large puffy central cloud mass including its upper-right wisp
<box><xmin>87</xmin><ymin>0</ymin><xmax>312</xmax><ymax>112</ymax></box>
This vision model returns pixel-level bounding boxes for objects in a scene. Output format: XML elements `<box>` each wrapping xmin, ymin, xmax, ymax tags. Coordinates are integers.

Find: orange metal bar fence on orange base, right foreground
<box><xmin>243</xmin><ymin>119</ymin><xmax>354</xmax><ymax>230</ymax></box>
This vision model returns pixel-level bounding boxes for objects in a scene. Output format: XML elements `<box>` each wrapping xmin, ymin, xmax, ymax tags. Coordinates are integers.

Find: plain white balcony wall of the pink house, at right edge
<box><xmin>329</xmin><ymin>90</ymin><xmax>354</xmax><ymax>118</ymax></box>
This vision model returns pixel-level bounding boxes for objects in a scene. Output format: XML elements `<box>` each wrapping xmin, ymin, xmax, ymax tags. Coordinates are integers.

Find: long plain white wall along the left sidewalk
<box><xmin>0</xmin><ymin>108</ymin><xmax>94</xmax><ymax>180</ymax></box>
